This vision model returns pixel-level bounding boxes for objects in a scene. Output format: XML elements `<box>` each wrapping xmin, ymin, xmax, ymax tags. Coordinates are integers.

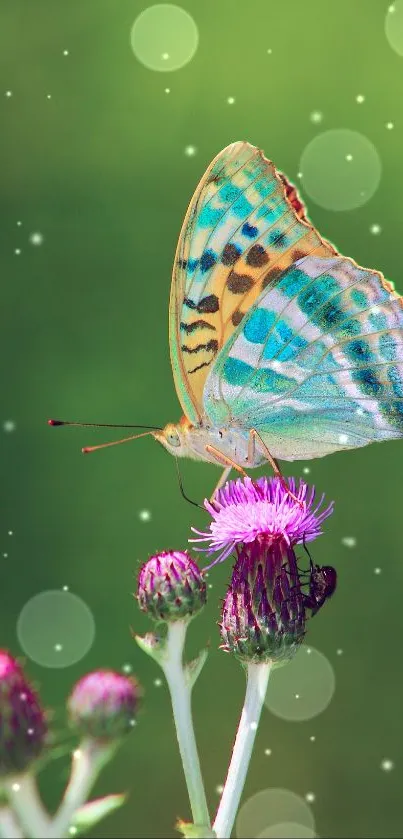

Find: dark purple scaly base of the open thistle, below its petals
<box><xmin>220</xmin><ymin>537</ymin><xmax>305</xmax><ymax>665</ymax></box>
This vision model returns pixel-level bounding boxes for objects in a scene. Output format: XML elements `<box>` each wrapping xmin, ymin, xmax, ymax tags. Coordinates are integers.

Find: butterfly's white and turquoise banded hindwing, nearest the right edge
<box><xmin>204</xmin><ymin>256</ymin><xmax>403</xmax><ymax>460</ymax></box>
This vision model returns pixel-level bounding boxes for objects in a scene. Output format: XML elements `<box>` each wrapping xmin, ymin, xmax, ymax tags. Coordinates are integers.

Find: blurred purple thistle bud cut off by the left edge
<box><xmin>0</xmin><ymin>650</ymin><xmax>47</xmax><ymax>778</ymax></box>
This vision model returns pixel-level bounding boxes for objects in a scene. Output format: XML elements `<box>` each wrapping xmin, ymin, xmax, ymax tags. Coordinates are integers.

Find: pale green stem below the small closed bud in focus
<box><xmin>160</xmin><ymin>621</ymin><xmax>210</xmax><ymax>827</ymax></box>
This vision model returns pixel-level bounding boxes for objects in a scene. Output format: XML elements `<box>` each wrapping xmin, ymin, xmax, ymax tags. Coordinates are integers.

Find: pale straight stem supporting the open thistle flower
<box><xmin>213</xmin><ymin>663</ymin><xmax>271</xmax><ymax>839</ymax></box>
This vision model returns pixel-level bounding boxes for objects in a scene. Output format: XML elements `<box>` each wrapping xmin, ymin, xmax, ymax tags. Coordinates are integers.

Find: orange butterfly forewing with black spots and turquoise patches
<box><xmin>169</xmin><ymin>142</ymin><xmax>337</xmax><ymax>423</ymax></box>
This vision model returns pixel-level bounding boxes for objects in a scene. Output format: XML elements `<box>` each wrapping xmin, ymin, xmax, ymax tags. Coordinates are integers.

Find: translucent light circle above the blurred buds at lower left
<box><xmin>17</xmin><ymin>590</ymin><xmax>95</xmax><ymax>667</ymax></box>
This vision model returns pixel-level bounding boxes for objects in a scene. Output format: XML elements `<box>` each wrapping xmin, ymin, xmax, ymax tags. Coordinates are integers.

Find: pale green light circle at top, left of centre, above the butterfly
<box><xmin>130</xmin><ymin>3</ymin><xmax>199</xmax><ymax>73</ymax></box>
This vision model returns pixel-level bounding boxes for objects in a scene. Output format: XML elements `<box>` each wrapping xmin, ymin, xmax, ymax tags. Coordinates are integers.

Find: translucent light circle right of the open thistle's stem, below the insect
<box><xmin>265</xmin><ymin>644</ymin><xmax>336</xmax><ymax>720</ymax></box>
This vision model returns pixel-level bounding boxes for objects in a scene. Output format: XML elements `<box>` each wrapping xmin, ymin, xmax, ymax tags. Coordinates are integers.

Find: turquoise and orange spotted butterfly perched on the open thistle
<box><xmin>151</xmin><ymin>142</ymin><xmax>403</xmax><ymax>496</ymax></box>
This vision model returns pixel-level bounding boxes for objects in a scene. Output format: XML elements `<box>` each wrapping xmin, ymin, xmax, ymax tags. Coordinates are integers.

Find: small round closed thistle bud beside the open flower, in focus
<box><xmin>137</xmin><ymin>551</ymin><xmax>207</xmax><ymax>621</ymax></box>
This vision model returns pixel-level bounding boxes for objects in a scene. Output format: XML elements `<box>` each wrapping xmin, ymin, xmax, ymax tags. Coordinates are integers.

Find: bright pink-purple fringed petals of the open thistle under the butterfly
<box><xmin>189</xmin><ymin>477</ymin><xmax>333</xmax><ymax>568</ymax></box>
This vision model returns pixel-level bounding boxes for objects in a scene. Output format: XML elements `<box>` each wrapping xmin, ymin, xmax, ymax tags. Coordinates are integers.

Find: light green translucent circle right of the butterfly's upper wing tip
<box><xmin>299</xmin><ymin>128</ymin><xmax>382</xmax><ymax>210</ymax></box>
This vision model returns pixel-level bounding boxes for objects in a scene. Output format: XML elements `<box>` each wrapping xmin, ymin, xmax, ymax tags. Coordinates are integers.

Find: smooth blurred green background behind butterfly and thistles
<box><xmin>0</xmin><ymin>0</ymin><xmax>403</xmax><ymax>837</ymax></box>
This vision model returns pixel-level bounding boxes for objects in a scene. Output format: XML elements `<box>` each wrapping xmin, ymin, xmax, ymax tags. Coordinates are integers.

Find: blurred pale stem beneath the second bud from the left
<box><xmin>43</xmin><ymin>740</ymin><xmax>115</xmax><ymax>839</ymax></box>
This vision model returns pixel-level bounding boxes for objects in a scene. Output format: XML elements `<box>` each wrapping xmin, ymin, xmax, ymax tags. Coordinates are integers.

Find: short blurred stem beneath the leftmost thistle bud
<box><xmin>4</xmin><ymin>773</ymin><xmax>50</xmax><ymax>839</ymax></box>
